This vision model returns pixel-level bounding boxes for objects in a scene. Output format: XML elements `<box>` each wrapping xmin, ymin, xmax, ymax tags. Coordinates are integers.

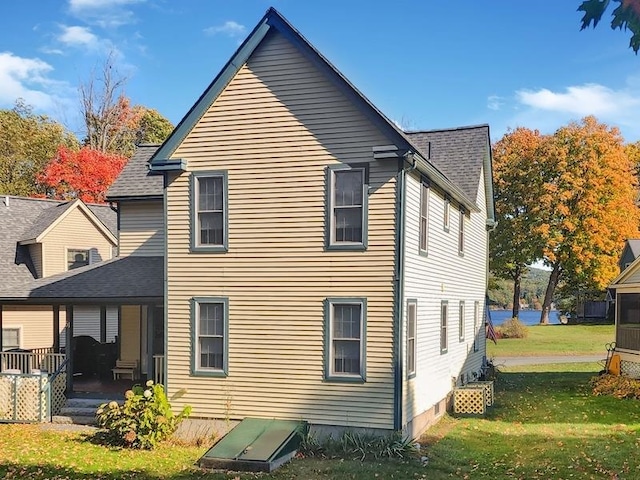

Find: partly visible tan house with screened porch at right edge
<box><xmin>609</xmin><ymin>240</ymin><xmax>640</xmax><ymax>377</ymax></box>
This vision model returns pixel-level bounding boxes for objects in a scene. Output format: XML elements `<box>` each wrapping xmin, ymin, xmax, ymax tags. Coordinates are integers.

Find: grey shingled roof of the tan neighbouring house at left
<box><xmin>0</xmin><ymin>195</ymin><xmax>117</xmax><ymax>291</ymax></box>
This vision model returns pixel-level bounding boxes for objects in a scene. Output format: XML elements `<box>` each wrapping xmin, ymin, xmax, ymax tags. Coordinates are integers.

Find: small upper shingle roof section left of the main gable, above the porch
<box><xmin>107</xmin><ymin>145</ymin><xmax>163</xmax><ymax>200</ymax></box>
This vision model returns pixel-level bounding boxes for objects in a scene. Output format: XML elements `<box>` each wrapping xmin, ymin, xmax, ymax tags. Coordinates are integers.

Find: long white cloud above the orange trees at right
<box><xmin>516</xmin><ymin>83</ymin><xmax>640</xmax><ymax>116</ymax></box>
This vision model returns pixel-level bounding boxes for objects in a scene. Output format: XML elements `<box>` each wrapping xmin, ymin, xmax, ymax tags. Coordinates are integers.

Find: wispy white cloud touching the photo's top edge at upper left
<box><xmin>69</xmin><ymin>0</ymin><xmax>146</xmax><ymax>28</ymax></box>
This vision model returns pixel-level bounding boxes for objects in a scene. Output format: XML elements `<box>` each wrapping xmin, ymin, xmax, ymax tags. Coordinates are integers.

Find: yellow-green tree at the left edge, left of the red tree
<box><xmin>0</xmin><ymin>100</ymin><xmax>78</xmax><ymax>196</ymax></box>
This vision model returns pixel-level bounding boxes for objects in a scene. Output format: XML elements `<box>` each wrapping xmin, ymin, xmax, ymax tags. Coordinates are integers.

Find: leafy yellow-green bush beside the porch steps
<box><xmin>96</xmin><ymin>380</ymin><xmax>191</xmax><ymax>449</ymax></box>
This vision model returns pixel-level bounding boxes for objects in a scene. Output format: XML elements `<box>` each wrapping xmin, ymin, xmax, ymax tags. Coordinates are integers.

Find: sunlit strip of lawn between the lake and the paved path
<box><xmin>487</xmin><ymin>325</ymin><xmax>614</xmax><ymax>358</ymax></box>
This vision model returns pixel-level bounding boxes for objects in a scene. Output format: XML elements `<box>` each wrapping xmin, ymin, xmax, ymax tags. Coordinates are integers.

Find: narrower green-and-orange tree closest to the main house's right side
<box><xmin>490</xmin><ymin>128</ymin><xmax>544</xmax><ymax>317</ymax></box>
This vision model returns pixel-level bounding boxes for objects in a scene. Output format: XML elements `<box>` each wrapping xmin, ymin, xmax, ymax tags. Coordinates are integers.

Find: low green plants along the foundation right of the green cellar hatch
<box><xmin>300</xmin><ymin>431</ymin><xmax>419</xmax><ymax>461</ymax></box>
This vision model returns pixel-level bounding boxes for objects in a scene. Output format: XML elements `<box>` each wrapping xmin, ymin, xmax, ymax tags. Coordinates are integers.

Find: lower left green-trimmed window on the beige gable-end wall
<box><xmin>191</xmin><ymin>297</ymin><xmax>229</xmax><ymax>376</ymax></box>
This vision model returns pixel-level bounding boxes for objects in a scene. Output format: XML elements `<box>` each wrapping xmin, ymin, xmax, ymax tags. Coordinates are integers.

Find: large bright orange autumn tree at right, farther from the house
<box><xmin>533</xmin><ymin>116</ymin><xmax>640</xmax><ymax>324</ymax></box>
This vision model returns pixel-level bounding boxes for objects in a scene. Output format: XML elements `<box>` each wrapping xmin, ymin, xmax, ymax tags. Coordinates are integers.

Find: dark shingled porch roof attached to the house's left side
<box><xmin>0</xmin><ymin>256</ymin><xmax>164</xmax><ymax>305</ymax></box>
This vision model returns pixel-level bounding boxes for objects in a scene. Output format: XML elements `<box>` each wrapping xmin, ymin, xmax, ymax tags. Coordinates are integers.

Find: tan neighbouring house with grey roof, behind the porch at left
<box><xmin>0</xmin><ymin>196</ymin><xmax>117</xmax><ymax>350</ymax></box>
